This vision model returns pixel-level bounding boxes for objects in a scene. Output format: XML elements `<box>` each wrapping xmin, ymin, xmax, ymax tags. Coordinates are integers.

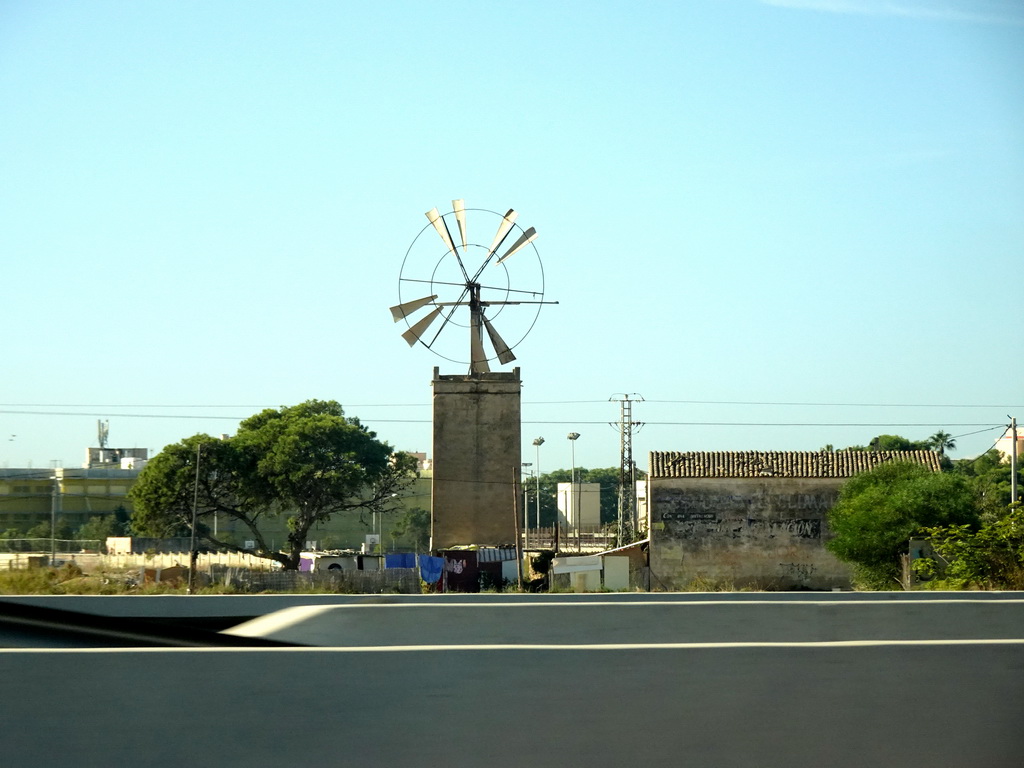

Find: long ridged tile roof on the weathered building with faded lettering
<box><xmin>648</xmin><ymin>451</ymin><xmax>941</xmax><ymax>477</ymax></box>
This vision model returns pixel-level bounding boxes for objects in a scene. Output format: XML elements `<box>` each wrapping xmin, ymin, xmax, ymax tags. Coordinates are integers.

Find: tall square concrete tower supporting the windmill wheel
<box><xmin>430</xmin><ymin>368</ymin><xmax>521</xmax><ymax>550</ymax></box>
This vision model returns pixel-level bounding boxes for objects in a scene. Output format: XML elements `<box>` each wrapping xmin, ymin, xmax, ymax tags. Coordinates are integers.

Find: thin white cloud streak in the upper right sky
<box><xmin>759</xmin><ymin>0</ymin><xmax>1024</xmax><ymax>27</ymax></box>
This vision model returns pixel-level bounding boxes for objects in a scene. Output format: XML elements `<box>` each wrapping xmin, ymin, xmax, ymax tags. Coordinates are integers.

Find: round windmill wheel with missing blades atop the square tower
<box><xmin>391</xmin><ymin>200</ymin><xmax>558</xmax><ymax>374</ymax></box>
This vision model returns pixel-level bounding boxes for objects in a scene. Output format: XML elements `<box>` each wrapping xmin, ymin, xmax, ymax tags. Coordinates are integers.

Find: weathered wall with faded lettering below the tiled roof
<box><xmin>650</xmin><ymin>477</ymin><xmax>851</xmax><ymax>590</ymax></box>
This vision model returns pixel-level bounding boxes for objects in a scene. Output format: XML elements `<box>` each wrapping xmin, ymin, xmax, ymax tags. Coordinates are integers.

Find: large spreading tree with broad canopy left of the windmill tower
<box><xmin>131</xmin><ymin>400</ymin><xmax>416</xmax><ymax>569</ymax></box>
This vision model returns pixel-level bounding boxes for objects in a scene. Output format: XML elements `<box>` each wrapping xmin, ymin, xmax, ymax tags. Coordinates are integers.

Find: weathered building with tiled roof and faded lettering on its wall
<box><xmin>647</xmin><ymin>451</ymin><xmax>941</xmax><ymax>591</ymax></box>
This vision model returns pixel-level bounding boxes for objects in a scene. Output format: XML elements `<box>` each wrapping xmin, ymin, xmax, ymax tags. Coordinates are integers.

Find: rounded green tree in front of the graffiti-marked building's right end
<box><xmin>825</xmin><ymin>462</ymin><xmax>978</xmax><ymax>589</ymax></box>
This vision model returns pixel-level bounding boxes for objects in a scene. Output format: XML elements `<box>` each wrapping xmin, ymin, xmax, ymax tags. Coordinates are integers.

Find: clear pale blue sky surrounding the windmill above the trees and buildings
<box><xmin>0</xmin><ymin>0</ymin><xmax>1024</xmax><ymax>470</ymax></box>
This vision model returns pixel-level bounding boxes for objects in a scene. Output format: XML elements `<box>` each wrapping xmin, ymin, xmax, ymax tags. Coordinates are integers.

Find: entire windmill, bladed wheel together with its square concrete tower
<box><xmin>391</xmin><ymin>200</ymin><xmax>557</xmax><ymax>551</ymax></box>
